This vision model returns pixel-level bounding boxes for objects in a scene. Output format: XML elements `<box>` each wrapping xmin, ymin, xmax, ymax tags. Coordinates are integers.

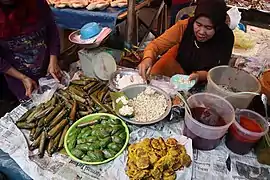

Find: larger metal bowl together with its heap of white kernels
<box><xmin>118</xmin><ymin>84</ymin><xmax>172</xmax><ymax>125</ymax></box>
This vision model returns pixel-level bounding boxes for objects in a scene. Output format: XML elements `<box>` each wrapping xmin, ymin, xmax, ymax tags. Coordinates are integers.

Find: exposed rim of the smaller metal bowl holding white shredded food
<box><xmin>109</xmin><ymin>68</ymin><xmax>146</xmax><ymax>91</ymax></box>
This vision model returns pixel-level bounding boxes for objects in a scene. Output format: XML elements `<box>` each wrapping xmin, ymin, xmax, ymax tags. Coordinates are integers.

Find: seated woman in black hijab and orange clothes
<box><xmin>139</xmin><ymin>0</ymin><xmax>234</xmax><ymax>81</ymax></box>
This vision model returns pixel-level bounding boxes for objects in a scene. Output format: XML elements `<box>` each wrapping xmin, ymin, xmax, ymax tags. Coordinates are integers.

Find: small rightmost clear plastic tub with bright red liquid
<box><xmin>225</xmin><ymin>109</ymin><xmax>269</xmax><ymax>155</ymax></box>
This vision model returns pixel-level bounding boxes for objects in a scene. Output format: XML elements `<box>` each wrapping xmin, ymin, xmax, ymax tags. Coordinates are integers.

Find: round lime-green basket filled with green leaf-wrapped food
<box><xmin>66</xmin><ymin>115</ymin><xmax>128</xmax><ymax>162</ymax></box>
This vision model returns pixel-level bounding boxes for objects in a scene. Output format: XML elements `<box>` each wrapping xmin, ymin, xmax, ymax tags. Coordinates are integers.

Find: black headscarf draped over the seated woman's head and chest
<box><xmin>177</xmin><ymin>0</ymin><xmax>234</xmax><ymax>74</ymax></box>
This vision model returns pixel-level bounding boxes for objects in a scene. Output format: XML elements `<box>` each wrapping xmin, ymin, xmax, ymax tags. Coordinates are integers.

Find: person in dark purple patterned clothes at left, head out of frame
<box><xmin>0</xmin><ymin>0</ymin><xmax>61</xmax><ymax>100</ymax></box>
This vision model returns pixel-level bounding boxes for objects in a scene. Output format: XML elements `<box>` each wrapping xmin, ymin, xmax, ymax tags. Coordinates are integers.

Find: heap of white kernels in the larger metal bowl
<box><xmin>128</xmin><ymin>87</ymin><xmax>168</xmax><ymax>122</ymax></box>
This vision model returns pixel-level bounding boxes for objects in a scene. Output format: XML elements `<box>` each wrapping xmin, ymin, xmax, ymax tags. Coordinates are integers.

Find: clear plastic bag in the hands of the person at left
<box><xmin>31</xmin><ymin>71</ymin><xmax>70</xmax><ymax>106</ymax></box>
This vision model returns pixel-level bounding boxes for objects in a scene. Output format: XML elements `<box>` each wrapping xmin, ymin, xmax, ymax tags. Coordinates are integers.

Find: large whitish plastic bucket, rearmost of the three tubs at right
<box><xmin>206</xmin><ymin>66</ymin><xmax>261</xmax><ymax>109</ymax></box>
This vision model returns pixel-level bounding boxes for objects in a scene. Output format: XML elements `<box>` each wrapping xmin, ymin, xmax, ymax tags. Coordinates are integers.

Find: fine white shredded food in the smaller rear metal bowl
<box><xmin>116</xmin><ymin>74</ymin><xmax>144</xmax><ymax>89</ymax></box>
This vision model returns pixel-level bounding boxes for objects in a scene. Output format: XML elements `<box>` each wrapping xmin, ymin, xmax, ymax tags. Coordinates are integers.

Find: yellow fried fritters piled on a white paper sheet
<box><xmin>102</xmin><ymin>129</ymin><xmax>193</xmax><ymax>180</ymax></box>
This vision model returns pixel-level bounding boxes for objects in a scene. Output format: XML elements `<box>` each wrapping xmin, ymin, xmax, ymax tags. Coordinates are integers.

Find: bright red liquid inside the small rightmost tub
<box><xmin>225</xmin><ymin>116</ymin><xmax>263</xmax><ymax>155</ymax></box>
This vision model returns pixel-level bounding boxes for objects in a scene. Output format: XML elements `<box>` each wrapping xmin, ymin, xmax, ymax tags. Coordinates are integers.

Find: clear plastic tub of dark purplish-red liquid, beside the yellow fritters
<box><xmin>184</xmin><ymin>93</ymin><xmax>235</xmax><ymax>150</ymax></box>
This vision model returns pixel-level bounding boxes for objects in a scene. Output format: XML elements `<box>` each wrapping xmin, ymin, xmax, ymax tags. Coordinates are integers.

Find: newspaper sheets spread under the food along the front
<box><xmin>0</xmin><ymin>106</ymin><xmax>270</xmax><ymax>180</ymax></box>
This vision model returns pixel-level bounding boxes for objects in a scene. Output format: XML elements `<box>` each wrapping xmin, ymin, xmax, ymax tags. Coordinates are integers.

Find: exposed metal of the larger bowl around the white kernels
<box><xmin>116</xmin><ymin>84</ymin><xmax>172</xmax><ymax>125</ymax></box>
